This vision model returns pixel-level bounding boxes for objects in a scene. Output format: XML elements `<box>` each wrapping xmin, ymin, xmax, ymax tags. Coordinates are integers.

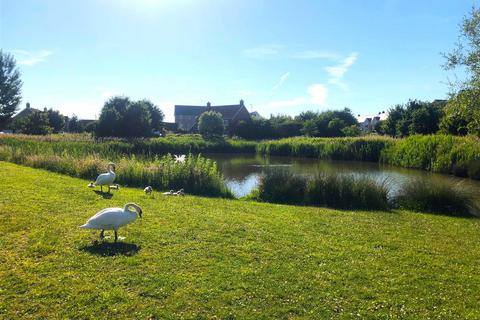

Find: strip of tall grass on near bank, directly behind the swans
<box><xmin>0</xmin><ymin>142</ymin><xmax>233</xmax><ymax>198</ymax></box>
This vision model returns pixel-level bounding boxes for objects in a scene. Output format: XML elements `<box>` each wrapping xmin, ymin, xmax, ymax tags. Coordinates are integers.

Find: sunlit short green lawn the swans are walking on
<box><xmin>0</xmin><ymin>162</ymin><xmax>480</xmax><ymax>319</ymax></box>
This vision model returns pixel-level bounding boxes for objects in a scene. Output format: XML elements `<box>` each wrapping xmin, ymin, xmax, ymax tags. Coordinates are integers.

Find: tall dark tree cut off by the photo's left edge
<box><xmin>0</xmin><ymin>50</ymin><xmax>22</xmax><ymax>125</ymax></box>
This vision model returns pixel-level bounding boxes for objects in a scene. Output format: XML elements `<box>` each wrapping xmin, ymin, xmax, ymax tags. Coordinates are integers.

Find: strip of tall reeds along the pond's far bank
<box><xmin>0</xmin><ymin>134</ymin><xmax>480</xmax><ymax>179</ymax></box>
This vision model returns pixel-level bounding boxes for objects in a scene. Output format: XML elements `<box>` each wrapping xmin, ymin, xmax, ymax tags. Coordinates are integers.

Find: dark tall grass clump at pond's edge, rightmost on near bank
<box><xmin>393</xmin><ymin>178</ymin><xmax>479</xmax><ymax>216</ymax></box>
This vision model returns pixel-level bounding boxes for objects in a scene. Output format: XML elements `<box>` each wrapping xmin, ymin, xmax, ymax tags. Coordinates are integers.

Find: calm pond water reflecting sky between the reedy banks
<box><xmin>204</xmin><ymin>153</ymin><xmax>480</xmax><ymax>197</ymax></box>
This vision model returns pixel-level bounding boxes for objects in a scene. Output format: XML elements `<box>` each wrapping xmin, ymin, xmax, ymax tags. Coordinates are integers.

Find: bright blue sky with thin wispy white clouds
<box><xmin>0</xmin><ymin>0</ymin><xmax>474</xmax><ymax>121</ymax></box>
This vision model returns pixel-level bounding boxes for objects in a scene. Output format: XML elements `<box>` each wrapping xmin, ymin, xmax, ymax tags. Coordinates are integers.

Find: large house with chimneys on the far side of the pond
<box><xmin>175</xmin><ymin>100</ymin><xmax>252</xmax><ymax>132</ymax></box>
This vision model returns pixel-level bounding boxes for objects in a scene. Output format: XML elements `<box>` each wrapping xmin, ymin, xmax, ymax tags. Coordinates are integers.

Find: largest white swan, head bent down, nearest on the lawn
<box><xmin>80</xmin><ymin>202</ymin><xmax>142</xmax><ymax>242</ymax></box>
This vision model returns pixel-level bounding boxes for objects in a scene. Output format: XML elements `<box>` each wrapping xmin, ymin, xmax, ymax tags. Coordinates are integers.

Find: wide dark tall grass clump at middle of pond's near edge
<box><xmin>255</xmin><ymin>170</ymin><xmax>388</xmax><ymax>210</ymax></box>
